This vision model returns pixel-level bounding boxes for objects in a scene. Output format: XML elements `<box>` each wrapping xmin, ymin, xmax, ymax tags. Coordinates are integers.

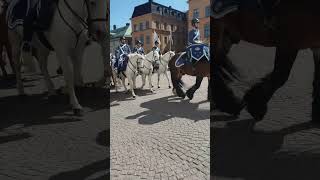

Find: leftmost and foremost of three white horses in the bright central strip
<box><xmin>116</xmin><ymin>53</ymin><xmax>145</xmax><ymax>98</ymax></box>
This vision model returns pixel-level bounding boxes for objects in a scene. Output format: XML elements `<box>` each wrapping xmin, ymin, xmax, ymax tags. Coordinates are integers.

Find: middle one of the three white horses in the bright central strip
<box><xmin>139</xmin><ymin>51</ymin><xmax>160</xmax><ymax>92</ymax></box>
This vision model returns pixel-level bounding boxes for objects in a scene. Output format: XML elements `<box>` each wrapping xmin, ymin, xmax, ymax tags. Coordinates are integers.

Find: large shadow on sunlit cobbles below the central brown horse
<box><xmin>126</xmin><ymin>96</ymin><xmax>210</xmax><ymax>124</ymax></box>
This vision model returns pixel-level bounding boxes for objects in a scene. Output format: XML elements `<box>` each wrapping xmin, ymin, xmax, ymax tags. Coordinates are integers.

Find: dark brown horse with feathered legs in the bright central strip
<box><xmin>168</xmin><ymin>53</ymin><xmax>211</xmax><ymax>100</ymax></box>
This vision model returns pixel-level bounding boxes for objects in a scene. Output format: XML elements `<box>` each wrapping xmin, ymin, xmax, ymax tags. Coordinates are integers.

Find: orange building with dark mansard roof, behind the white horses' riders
<box><xmin>131</xmin><ymin>0</ymin><xmax>188</xmax><ymax>53</ymax></box>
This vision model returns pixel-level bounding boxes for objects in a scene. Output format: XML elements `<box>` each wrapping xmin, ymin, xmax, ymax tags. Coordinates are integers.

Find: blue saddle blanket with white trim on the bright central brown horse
<box><xmin>175</xmin><ymin>44</ymin><xmax>210</xmax><ymax>67</ymax></box>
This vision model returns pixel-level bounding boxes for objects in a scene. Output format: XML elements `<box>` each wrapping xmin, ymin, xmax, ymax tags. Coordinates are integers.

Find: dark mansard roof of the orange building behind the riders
<box><xmin>131</xmin><ymin>0</ymin><xmax>186</xmax><ymax>20</ymax></box>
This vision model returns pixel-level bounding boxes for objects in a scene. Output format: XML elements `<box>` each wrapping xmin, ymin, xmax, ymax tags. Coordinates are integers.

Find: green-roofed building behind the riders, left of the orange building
<box><xmin>110</xmin><ymin>23</ymin><xmax>132</xmax><ymax>54</ymax></box>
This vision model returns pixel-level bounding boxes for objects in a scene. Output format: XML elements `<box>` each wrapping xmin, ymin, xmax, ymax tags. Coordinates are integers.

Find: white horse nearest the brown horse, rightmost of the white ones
<box><xmin>155</xmin><ymin>51</ymin><xmax>175</xmax><ymax>88</ymax></box>
